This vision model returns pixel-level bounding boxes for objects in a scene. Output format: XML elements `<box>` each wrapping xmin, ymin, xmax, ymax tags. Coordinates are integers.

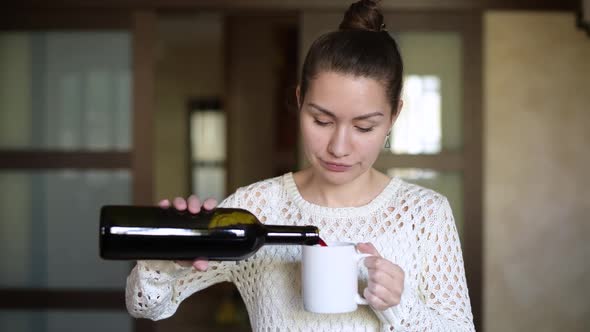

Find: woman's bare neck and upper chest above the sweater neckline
<box><xmin>293</xmin><ymin>168</ymin><xmax>390</xmax><ymax>208</ymax></box>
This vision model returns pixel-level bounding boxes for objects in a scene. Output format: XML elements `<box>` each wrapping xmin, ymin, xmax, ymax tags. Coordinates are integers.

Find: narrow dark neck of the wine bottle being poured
<box><xmin>264</xmin><ymin>225</ymin><xmax>320</xmax><ymax>245</ymax></box>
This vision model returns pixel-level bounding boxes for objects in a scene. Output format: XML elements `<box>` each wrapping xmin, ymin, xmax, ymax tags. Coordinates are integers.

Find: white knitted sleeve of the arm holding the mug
<box><xmin>376</xmin><ymin>197</ymin><xmax>475</xmax><ymax>332</ymax></box>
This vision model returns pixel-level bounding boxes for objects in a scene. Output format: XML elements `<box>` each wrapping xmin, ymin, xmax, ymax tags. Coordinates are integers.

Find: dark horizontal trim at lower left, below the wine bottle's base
<box><xmin>0</xmin><ymin>288</ymin><xmax>125</xmax><ymax>310</ymax></box>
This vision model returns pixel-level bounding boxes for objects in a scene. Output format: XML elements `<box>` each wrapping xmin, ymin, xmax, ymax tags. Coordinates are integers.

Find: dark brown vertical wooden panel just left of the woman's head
<box><xmin>226</xmin><ymin>16</ymin><xmax>280</xmax><ymax>192</ymax></box>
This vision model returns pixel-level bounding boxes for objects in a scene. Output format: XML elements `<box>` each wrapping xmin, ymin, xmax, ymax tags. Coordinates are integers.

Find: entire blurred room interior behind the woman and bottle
<box><xmin>0</xmin><ymin>0</ymin><xmax>590</xmax><ymax>332</ymax></box>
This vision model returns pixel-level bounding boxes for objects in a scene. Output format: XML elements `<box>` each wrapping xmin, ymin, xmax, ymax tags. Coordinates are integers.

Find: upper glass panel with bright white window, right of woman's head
<box><xmin>391</xmin><ymin>32</ymin><xmax>463</xmax><ymax>154</ymax></box>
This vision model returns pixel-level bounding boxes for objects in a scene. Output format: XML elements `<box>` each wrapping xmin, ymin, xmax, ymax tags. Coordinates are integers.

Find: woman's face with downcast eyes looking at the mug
<box><xmin>297</xmin><ymin>72</ymin><xmax>394</xmax><ymax>184</ymax></box>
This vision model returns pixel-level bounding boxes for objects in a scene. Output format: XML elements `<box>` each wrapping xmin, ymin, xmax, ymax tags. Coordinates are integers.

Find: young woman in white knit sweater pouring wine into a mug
<box><xmin>126</xmin><ymin>0</ymin><xmax>474</xmax><ymax>331</ymax></box>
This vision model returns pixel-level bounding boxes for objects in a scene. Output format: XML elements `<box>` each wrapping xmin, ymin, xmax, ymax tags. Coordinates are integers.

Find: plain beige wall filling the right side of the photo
<box><xmin>484</xmin><ymin>12</ymin><xmax>590</xmax><ymax>332</ymax></box>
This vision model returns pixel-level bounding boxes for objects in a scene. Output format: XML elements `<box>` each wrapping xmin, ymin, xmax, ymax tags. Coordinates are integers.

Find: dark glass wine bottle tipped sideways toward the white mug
<box><xmin>99</xmin><ymin>205</ymin><xmax>320</xmax><ymax>260</ymax></box>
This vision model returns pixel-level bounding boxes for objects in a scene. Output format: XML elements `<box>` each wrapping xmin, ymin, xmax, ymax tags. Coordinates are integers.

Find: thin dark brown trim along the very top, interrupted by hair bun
<box><xmin>3</xmin><ymin>0</ymin><xmax>578</xmax><ymax>10</ymax></box>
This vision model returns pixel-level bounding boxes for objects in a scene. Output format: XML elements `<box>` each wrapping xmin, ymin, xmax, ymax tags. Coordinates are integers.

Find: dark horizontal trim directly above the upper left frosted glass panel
<box><xmin>0</xmin><ymin>6</ymin><xmax>132</xmax><ymax>31</ymax></box>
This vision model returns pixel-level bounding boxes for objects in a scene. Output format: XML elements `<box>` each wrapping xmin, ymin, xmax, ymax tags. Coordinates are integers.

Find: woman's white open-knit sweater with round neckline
<box><xmin>126</xmin><ymin>173</ymin><xmax>474</xmax><ymax>332</ymax></box>
